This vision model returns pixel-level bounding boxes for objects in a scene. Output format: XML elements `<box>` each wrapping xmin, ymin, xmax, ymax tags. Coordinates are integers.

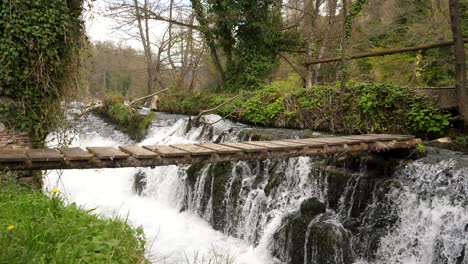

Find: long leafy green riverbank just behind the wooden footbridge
<box><xmin>159</xmin><ymin>83</ymin><xmax>452</xmax><ymax>137</ymax></box>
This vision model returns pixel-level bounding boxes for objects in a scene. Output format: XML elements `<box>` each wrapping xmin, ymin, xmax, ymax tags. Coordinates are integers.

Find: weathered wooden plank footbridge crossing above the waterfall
<box><xmin>0</xmin><ymin>135</ymin><xmax>421</xmax><ymax>170</ymax></box>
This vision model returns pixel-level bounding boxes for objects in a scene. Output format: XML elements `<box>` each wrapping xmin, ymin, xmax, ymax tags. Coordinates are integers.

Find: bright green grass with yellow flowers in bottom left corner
<box><xmin>0</xmin><ymin>180</ymin><xmax>147</xmax><ymax>264</ymax></box>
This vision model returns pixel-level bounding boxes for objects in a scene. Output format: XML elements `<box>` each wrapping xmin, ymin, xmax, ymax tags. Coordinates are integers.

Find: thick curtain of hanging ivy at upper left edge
<box><xmin>0</xmin><ymin>0</ymin><xmax>83</xmax><ymax>146</ymax></box>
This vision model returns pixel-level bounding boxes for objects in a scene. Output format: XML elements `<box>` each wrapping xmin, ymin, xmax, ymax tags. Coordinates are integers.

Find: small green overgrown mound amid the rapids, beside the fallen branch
<box><xmin>98</xmin><ymin>97</ymin><xmax>156</xmax><ymax>141</ymax></box>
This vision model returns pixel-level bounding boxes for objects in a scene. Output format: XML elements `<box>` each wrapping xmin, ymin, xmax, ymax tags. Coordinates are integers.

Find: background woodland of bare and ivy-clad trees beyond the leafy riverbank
<box><xmin>86</xmin><ymin>0</ymin><xmax>468</xmax><ymax>97</ymax></box>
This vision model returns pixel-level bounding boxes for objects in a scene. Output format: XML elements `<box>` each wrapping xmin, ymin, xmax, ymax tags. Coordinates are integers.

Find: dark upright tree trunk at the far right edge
<box><xmin>449</xmin><ymin>0</ymin><xmax>468</xmax><ymax>129</ymax></box>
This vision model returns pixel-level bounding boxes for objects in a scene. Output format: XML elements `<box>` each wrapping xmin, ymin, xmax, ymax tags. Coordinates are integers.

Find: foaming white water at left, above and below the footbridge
<box><xmin>44</xmin><ymin>116</ymin><xmax>273</xmax><ymax>264</ymax></box>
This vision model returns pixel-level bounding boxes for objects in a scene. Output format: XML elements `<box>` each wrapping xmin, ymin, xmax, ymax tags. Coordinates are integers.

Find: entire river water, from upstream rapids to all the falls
<box><xmin>45</xmin><ymin>113</ymin><xmax>468</xmax><ymax>264</ymax></box>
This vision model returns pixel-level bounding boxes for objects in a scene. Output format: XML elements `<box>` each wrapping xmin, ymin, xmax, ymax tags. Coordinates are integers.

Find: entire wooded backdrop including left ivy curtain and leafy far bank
<box><xmin>0</xmin><ymin>0</ymin><xmax>468</xmax><ymax>142</ymax></box>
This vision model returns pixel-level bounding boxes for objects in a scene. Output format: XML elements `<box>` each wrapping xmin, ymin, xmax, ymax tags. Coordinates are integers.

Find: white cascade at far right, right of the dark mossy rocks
<box><xmin>372</xmin><ymin>156</ymin><xmax>468</xmax><ymax>264</ymax></box>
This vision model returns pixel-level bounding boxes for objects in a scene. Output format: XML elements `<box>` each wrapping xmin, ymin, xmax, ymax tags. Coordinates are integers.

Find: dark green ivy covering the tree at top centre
<box><xmin>196</xmin><ymin>0</ymin><xmax>301</xmax><ymax>91</ymax></box>
